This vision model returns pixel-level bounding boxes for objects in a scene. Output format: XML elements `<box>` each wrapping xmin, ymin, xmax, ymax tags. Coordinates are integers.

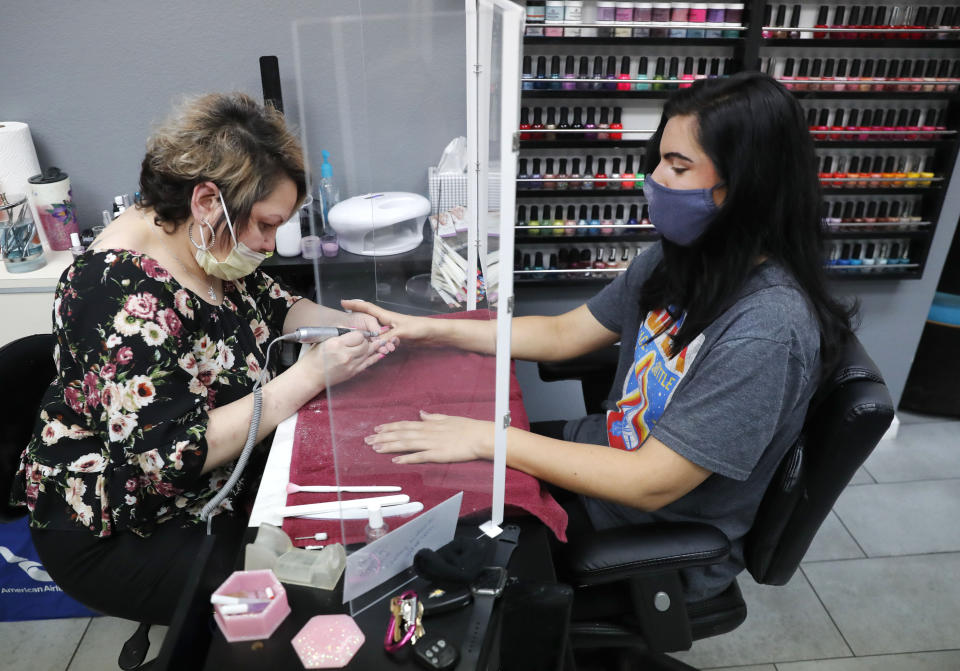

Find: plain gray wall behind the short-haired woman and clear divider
<box><xmin>0</xmin><ymin>0</ymin><xmax>466</xmax><ymax>228</ymax></box>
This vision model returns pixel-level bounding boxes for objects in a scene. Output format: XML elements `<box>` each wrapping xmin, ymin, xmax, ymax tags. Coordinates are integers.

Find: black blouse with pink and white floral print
<box><xmin>13</xmin><ymin>250</ymin><xmax>299</xmax><ymax>536</ymax></box>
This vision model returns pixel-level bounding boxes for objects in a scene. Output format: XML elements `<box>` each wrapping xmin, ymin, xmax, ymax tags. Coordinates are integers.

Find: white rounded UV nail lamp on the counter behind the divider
<box><xmin>327</xmin><ymin>196</ymin><xmax>430</xmax><ymax>256</ymax></box>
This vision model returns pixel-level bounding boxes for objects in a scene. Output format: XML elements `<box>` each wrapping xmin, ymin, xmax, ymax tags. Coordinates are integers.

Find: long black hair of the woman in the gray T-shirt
<box><xmin>640</xmin><ymin>72</ymin><xmax>857</xmax><ymax>371</ymax></box>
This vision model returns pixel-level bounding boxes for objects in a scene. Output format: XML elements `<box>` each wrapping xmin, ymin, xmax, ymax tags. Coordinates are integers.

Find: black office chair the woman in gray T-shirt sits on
<box><xmin>540</xmin><ymin>337</ymin><xmax>894</xmax><ymax>670</ymax></box>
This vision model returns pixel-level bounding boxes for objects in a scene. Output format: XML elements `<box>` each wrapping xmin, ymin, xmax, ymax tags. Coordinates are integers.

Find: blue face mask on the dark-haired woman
<box><xmin>643</xmin><ymin>175</ymin><xmax>722</xmax><ymax>247</ymax></box>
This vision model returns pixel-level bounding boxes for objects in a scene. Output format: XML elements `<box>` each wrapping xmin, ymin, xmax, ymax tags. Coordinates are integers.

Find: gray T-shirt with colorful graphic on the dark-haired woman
<box><xmin>564</xmin><ymin>245</ymin><xmax>820</xmax><ymax>601</ymax></box>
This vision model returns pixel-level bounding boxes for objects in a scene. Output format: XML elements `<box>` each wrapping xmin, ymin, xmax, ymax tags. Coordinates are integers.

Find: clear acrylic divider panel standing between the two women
<box><xmin>286</xmin><ymin>0</ymin><xmax>520</xmax><ymax>614</ymax></box>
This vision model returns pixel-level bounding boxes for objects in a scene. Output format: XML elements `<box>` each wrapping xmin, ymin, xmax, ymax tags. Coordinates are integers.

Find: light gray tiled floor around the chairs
<box><xmin>0</xmin><ymin>413</ymin><xmax>960</xmax><ymax>671</ymax></box>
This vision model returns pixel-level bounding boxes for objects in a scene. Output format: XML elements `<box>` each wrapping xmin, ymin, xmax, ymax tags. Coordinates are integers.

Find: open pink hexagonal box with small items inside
<box><xmin>210</xmin><ymin>569</ymin><xmax>290</xmax><ymax>642</ymax></box>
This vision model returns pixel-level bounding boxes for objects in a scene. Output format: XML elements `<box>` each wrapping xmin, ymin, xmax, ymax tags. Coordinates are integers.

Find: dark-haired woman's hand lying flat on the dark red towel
<box><xmin>364</xmin><ymin>410</ymin><xmax>493</xmax><ymax>464</ymax></box>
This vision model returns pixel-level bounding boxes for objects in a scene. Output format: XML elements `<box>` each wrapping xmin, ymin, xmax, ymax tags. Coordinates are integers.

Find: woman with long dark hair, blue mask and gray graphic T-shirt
<box><xmin>343</xmin><ymin>73</ymin><xmax>853</xmax><ymax>601</ymax></box>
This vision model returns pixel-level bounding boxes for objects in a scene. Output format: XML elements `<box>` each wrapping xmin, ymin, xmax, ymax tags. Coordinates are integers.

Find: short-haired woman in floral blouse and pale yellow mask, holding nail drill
<box><xmin>7</xmin><ymin>94</ymin><xmax>393</xmax><ymax>623</ymax></box>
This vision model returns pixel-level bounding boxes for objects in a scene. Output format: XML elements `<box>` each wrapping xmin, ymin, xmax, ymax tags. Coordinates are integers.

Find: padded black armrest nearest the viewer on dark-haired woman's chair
<box><xmin>565</xmin><ymin>522</ymin><xmax>730</xmax><ymax>585</ymax></box>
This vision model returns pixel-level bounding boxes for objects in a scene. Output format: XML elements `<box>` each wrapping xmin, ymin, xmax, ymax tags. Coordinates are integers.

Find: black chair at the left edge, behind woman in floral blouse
<box><xmin>0</xmin><ymin>333</ymin><xmax>156</xmax><ymax>669</ymax></box>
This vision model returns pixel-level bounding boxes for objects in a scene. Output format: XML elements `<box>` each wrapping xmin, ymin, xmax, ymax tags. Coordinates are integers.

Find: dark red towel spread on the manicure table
<box><xmin>283</xmin><ymin>310</ymin><xmax>567</xmax><ymax>545</ymax></box>
